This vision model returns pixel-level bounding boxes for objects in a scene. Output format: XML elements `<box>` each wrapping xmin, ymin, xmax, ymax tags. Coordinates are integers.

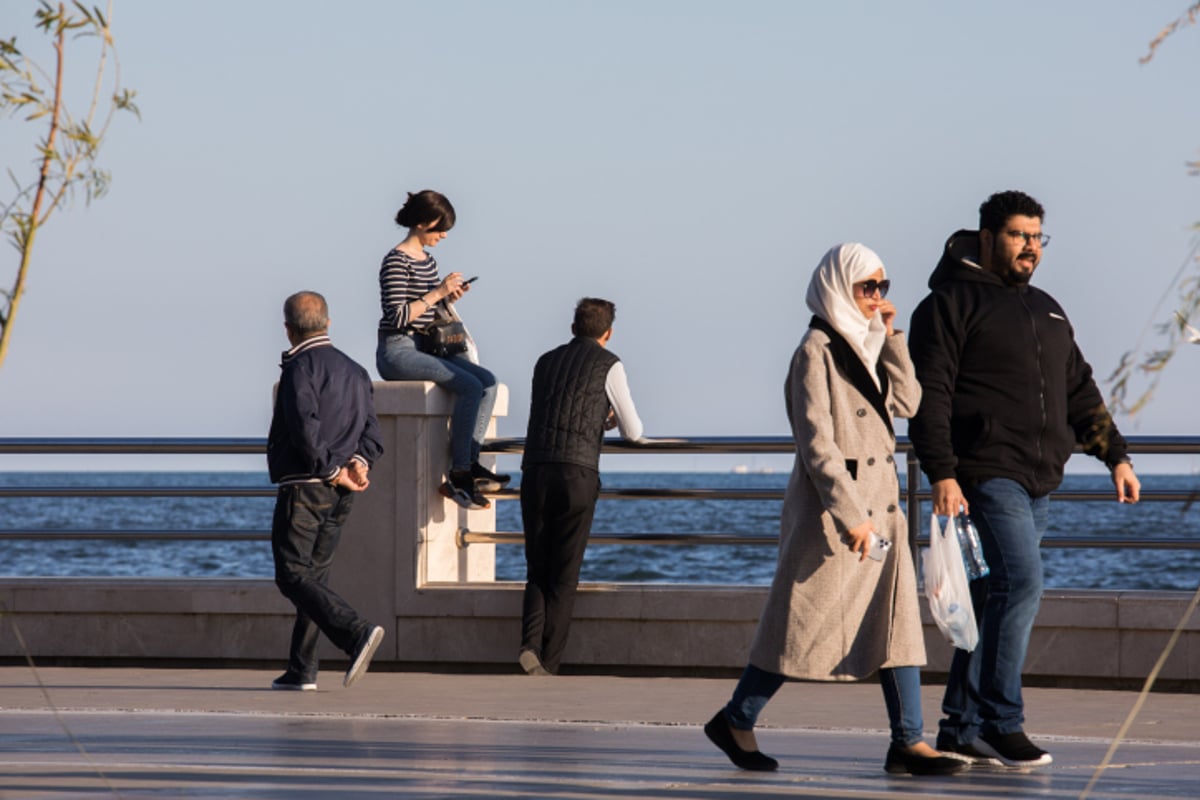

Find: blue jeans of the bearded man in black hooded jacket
<box><xmin>938</xmin><ymin>479</ymin><xmax>1050</xmax><ymax>744</ymax></box>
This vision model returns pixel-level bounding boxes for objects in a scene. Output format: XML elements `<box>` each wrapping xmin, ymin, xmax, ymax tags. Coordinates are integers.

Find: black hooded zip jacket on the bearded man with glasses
<box><xmin>908</xmin><ymin>230</ymin><xmax>1127</xmax><ymax>497</ymax></box>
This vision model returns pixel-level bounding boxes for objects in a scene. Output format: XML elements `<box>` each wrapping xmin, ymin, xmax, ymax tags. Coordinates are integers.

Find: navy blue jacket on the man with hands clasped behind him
<box><xmin>266</xmin><ymin>336</ymin><xmax>383</xmax><ymax>483</ymax></box>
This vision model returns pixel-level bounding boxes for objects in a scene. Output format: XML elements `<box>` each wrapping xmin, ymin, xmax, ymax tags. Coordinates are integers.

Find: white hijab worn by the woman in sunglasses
<box><xmin>806</xmin><ymin>242</ymin><xmax>888</xmax><ymax>385</ymax></box>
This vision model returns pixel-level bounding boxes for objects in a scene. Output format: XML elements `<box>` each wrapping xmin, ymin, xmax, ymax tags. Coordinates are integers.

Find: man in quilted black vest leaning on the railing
<box><xmin>520</xmin><ymin>297</ymin><xmax>642</xmax><ymax>675</ymax></box>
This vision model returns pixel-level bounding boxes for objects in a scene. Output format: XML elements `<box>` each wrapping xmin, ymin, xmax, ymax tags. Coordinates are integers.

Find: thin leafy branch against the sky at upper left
<box><xmin>0</xmin><ymin>0</ymin><xmax>140</xmax><ymax>365</ymax></box>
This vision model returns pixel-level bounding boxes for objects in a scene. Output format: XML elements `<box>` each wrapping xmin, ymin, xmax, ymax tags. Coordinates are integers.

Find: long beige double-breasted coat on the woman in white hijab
<box><xmin>750</xmin><ymin>319</ymin><xmax>925</xmax><ymax>680</ymax></box>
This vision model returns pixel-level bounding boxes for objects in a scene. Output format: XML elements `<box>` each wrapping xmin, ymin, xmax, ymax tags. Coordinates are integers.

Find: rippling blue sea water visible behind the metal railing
<box><xmin>0</xmin><ymin>473</ymin><xmax>1200</xmax><ymax>591</ymax></box>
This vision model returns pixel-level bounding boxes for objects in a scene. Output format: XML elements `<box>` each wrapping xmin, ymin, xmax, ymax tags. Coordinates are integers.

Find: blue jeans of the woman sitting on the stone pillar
<box><xmin>376</xmin><ymin>333</ymin><xmax>496</xmax><ymax>469</ymax></box>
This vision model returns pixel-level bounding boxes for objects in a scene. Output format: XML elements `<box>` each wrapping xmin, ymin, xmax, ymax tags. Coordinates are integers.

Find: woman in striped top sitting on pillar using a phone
<box><xmin>376</xmin><ymin>190</ymin><xmax>509</xmax><ymax>509</ymax></box>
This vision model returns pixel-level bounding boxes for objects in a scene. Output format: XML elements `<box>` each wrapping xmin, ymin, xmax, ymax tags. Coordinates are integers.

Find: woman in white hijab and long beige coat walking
<box><xmin>704</xmin><ymin>243</ymin><xmax>966</xmax><ymax>775</ymax></box>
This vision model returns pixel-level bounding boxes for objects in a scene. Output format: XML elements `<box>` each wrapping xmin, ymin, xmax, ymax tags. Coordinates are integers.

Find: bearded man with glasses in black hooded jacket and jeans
<box><xmin>908</xmin><ymin>192</ymin><xmax>1140</xmax><ymax>766</ymax></box>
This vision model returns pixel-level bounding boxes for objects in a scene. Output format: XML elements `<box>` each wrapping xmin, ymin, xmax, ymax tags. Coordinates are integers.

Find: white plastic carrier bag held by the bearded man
<box><xmin>922</xmin><ymin>515</ymin><xmax>979</xmax><ymax>652</ymax></box>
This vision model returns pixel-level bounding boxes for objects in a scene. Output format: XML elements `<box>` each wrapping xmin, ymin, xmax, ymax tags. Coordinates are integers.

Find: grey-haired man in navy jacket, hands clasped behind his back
<box><xmin>266</xmin><ymin>291</ymin><xmax>383</xmax><ymax>691</ymax></box>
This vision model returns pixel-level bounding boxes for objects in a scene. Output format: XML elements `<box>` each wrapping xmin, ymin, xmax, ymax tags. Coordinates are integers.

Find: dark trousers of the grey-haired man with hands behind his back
<box><xmin>271</xmin><ymin>483</ymin><xmax>370</xmax><ymax>681</ymax></box>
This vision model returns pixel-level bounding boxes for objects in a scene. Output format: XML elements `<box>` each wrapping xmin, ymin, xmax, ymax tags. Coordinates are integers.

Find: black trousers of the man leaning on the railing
<box><xmin>521</xmin><ymin>464</ymin><xmax>600</xmax><ymax>673</ymax></box>
